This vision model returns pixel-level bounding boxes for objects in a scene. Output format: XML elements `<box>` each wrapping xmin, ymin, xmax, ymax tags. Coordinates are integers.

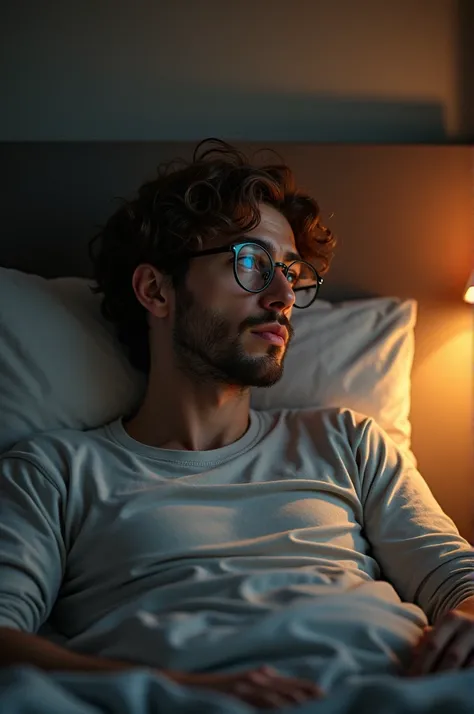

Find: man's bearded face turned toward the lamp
<box><xmin>172</xmin><ymin>204</ymin><xmax>297</xmax><ymax>388</ymax></box>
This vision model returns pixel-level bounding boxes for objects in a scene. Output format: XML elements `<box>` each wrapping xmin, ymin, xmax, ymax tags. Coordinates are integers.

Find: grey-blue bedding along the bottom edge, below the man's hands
<box><xmin>0</xmin><ymin>667</ymin><xmax>474</xmax><ymax>714</ymax></box>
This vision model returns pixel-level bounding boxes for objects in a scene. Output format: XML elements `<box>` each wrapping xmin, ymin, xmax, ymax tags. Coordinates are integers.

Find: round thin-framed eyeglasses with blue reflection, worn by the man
<box><xmin>189</xmin><ymin>241</ymin><xmax>323</xmax><ymax>309</ymax></box>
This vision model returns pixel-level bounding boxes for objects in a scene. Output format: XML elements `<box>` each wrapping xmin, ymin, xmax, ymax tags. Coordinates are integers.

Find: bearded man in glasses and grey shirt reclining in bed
<box><xmin>0</xmin><ymin>142</ymin><xmax>474</xmax><ymax>708</ymax></box>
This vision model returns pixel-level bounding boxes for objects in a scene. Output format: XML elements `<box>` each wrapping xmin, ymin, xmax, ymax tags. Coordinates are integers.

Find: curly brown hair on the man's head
<box><xmin>89</xmin><ymin>139</ymin><xmax>336</xmax><ymax>374</ymax></box>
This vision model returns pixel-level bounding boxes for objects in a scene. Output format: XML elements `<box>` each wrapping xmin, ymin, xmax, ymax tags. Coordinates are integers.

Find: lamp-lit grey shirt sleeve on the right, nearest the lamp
<box><xmin>355</xmin><ymin>419</ymin><xmax>474</xmax><ymax>623</ymax></box>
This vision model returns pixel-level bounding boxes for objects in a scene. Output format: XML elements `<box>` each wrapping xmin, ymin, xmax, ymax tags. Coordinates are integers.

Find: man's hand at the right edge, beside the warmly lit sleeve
<box><xmin>407</xmin><ymin>608</ymin><xmax>474</xmax><ymax>677</ymax></box>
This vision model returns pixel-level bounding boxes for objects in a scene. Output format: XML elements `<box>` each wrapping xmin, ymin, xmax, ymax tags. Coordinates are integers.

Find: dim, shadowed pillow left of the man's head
<box><xmin>0</xmin><ymin>268</ymin><xmax>144</xmax><ymax>453</ymax></box>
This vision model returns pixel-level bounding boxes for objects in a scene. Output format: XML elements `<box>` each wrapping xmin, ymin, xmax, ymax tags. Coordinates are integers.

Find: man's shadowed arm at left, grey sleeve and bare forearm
<box><xmin>0</xmin><ymin>452</ymin><xmax>181</xmax><ymax>678</ymax></box>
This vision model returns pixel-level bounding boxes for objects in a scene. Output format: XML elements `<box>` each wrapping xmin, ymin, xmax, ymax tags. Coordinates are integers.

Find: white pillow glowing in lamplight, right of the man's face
<box><xmin>251</xmin><ymin>298</ymin><xmax>417</xmax><ymax>465</ymax></box>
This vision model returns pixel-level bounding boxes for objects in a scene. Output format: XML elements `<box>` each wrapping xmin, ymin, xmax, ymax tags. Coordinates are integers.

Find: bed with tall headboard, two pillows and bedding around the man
<box><xmin>0</xmin><ymin>142</ymin><xmax>474</xmax><ymax>714</ymax></box>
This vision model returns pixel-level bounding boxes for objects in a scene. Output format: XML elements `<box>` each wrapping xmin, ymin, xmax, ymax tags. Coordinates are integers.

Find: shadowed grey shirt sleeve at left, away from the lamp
<box><xmin>0</xmin><ymin>452</ymin><xmax>66</xmax><ymax>633</ymax></box>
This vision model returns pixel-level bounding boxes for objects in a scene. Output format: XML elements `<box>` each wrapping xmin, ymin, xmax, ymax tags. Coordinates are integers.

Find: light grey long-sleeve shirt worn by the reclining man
<box><xmin>0</xmin><ymin>409</ymin><xmax>474</xmax><ymax>688</ymax></box>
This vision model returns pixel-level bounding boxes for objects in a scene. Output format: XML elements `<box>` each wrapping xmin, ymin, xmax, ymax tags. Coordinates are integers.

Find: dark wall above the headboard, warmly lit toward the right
<box><xmin>0</xmin><ymin>0</ymin><xmax>466</xmax><ymax>143</ymax></box>
